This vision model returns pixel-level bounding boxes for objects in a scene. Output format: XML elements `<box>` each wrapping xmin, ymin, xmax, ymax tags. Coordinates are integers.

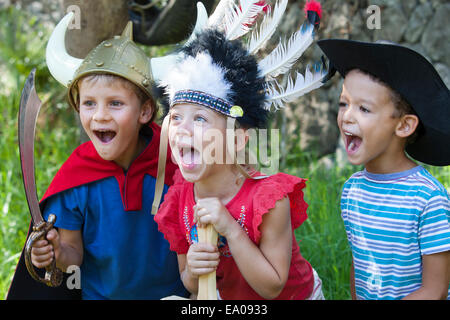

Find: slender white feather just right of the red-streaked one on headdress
<box><xmin>248</xmin><ymin>0</ymin><xmax>288</xmax><ymax>54</ymax></box>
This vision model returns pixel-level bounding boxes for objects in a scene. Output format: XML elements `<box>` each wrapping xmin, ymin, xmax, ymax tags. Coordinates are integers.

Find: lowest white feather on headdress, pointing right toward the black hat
<box><xmin>265</xmin><ymin>66</ymin><xmax>327</xmax><ymax>110</ymax></box>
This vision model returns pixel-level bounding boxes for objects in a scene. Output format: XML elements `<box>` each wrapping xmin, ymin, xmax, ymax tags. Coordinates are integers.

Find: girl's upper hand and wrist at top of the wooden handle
<box><xmin>194</xmin><ymin>198</ymin><xmax>236</xmax><ymax>237</ymax></box>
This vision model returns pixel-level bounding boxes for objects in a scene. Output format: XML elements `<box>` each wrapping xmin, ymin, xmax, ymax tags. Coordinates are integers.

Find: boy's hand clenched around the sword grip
<box><xmin>31</xmin><ymin>229</ymin><xmax>61</xmax><ymax>268</ymax></box>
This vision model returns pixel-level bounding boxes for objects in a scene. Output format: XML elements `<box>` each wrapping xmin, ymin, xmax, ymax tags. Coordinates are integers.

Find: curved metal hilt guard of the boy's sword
<box><xmin>25</xmin><ymin>214</ymin><xmax>63</xmax><ymax>287</ymax></box>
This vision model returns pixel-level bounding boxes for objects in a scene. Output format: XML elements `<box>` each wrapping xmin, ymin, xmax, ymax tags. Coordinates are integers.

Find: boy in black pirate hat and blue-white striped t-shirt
<box><xmin>318</xmin><ymin>39</ymin><xmax>450</xmax><ymax>299</ymax></box>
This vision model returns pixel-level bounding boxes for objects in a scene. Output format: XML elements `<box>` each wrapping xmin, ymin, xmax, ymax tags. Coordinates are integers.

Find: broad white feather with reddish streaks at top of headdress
<box><xmin>225</xmin><ymin>0</ymin><xmax>264</xmax><ymax>40</ymax></box>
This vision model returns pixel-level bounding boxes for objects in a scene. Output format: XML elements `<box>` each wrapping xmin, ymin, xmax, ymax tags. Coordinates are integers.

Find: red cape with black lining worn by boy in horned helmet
<box><xmin>7</xmin><ymin>123</ymin><xmax>177</xmax><ymax>300</ymax></box>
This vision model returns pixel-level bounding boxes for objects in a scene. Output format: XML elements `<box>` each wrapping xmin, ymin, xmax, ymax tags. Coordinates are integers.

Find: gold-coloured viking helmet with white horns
<box><xmin>46</xmin><ymin>3</ymin><xmax>208</xmax><ymax>111</ymax></box>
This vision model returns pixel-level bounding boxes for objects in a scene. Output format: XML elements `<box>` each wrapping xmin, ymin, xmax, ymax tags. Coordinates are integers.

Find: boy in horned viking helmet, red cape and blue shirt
<box><xmin>9</xmin><ymin>14</ymin><xmax>186</xmax><ymax>299</ymax></box>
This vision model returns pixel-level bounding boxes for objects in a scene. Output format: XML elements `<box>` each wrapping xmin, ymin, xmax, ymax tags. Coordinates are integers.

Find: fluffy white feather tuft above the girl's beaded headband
<box><xmin>160</xmin><ymin>52</ymin><xmax>231</xmax><ymax>101</ymax></box>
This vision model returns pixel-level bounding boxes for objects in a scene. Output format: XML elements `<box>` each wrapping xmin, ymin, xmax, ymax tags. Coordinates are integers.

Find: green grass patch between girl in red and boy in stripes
<box><xmin>290</xmin><ymin>167</ymin><xmax>352</xmax><ymax>300</ymax></box>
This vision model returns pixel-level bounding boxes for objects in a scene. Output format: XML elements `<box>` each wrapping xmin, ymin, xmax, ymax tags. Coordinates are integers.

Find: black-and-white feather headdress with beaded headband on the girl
<box><xmin>152</xmin><ymin>0</ymin><xmax>327</xmax><ymax>214</ymax></box>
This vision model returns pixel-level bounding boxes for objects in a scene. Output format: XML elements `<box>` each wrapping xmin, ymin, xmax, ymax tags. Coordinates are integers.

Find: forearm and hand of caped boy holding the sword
<box><xmin>31</xmin><ymin>229</ymin><xmax>83</xmax><ymax>271</ymax></box>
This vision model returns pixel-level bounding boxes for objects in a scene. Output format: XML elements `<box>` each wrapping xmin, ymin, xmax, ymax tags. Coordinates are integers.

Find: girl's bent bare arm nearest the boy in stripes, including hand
<box><xmin>197</xmin><ymin>198</ymin><xmax>292</xmax><ymax>299</ymax></box>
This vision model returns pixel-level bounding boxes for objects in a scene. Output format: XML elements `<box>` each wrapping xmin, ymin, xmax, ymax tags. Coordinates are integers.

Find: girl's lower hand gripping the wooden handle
<box><xmin>186</xmin><ymin>243</ymin><xmax>220</xmax><ymax>277</ymax></box>
